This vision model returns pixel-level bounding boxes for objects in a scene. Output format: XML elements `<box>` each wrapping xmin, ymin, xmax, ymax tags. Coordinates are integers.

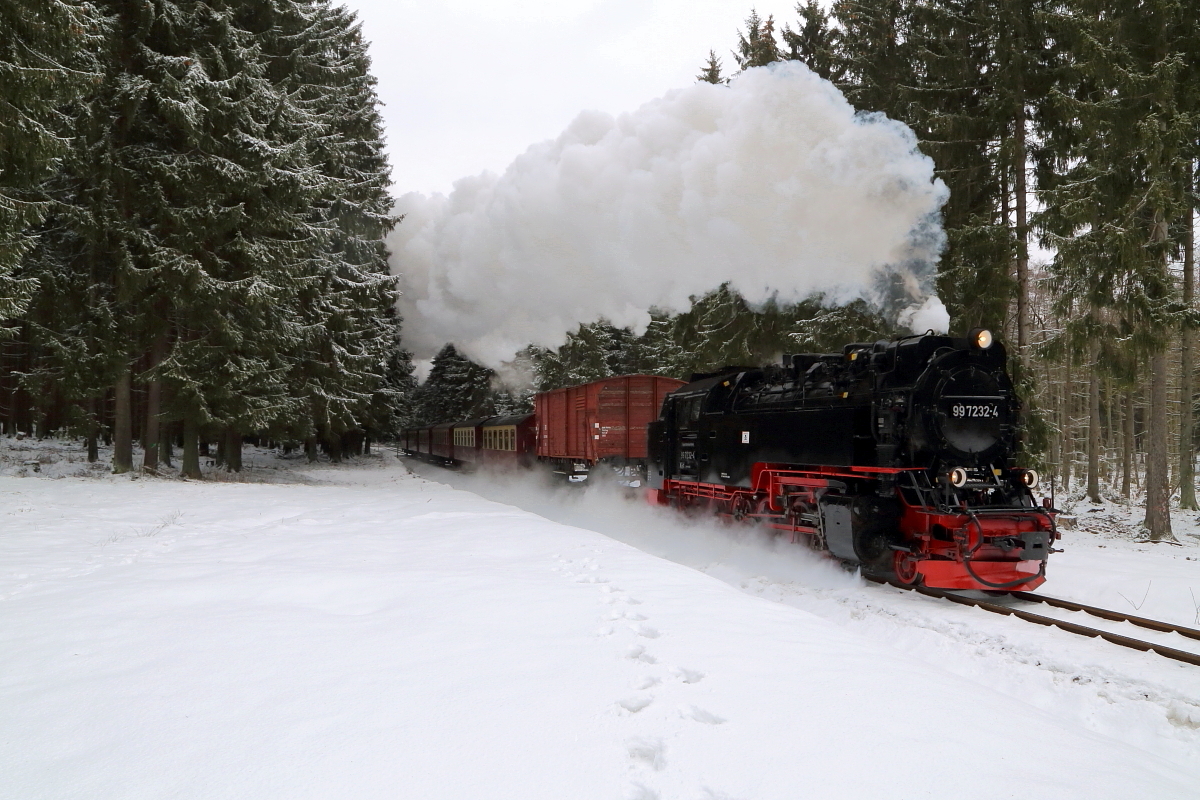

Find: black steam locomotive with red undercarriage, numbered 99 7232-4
<box><xmin>647</xmin><ymin>330</ymin><xmax>1057</xmax><ymax>590</ymax></box>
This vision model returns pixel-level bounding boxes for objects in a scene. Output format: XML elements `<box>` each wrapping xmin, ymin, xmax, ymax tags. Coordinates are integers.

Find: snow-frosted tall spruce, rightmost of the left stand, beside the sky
<box><xmin>253</xmin><ymin>0</ymin><xmax>408</xmax><ymax>450</ymax></box>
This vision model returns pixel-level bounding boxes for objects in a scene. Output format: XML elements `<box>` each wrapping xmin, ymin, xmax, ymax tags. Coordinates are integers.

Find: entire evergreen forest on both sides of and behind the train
<box><xmin>0</xmin><ymin>0</ymin><xmax>1200</xmax><ymax>537</ymax></box>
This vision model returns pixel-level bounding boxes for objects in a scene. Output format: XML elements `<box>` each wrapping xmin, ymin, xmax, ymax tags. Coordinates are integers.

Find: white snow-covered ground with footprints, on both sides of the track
<box><xmin>0</xmin><ymin>441</ymin><xmax>1200</xmax><ymax>800</ymax></box>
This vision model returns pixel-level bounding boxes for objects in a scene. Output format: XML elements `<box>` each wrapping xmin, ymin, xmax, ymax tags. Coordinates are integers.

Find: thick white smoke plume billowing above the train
<box><xmin>389</xmin><ymin>61</ymin><xmax>947</xmax><ymax>366</ymax></box>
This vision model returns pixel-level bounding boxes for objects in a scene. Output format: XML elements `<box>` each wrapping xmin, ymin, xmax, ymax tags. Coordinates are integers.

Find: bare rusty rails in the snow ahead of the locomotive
<box><xmin>864</xmin><ymin>576</ymin><xmax>1200</xmax><ymax>667</ymax></box>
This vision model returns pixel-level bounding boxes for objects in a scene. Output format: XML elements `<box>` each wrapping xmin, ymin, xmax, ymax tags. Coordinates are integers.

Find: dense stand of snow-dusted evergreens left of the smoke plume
<box><xmin>0</xmin><ymin>0</ymin><xmax>412</xmax><ymax>476</ymax></box>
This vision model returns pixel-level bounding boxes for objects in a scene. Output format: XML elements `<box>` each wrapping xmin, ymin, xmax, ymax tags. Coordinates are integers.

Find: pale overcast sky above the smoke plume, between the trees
<box><xmin>344</xmin><ymin>0</ymin><xmax>797</xmax><ymax>196</ymax></box>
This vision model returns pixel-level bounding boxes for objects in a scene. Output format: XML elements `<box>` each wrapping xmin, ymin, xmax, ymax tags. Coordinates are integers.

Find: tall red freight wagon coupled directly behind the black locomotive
<box><xmin>534</xmin><ymin>375</ymin><xmax>685</xmax><ymax>476</ymax></box>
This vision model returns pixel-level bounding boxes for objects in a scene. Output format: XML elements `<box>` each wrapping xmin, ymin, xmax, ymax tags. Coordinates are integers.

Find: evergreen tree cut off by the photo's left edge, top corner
<box><xmin>0</xmin><ymin>0</ymin><xmax>102</xmax><ymax>328</ymax></box>
